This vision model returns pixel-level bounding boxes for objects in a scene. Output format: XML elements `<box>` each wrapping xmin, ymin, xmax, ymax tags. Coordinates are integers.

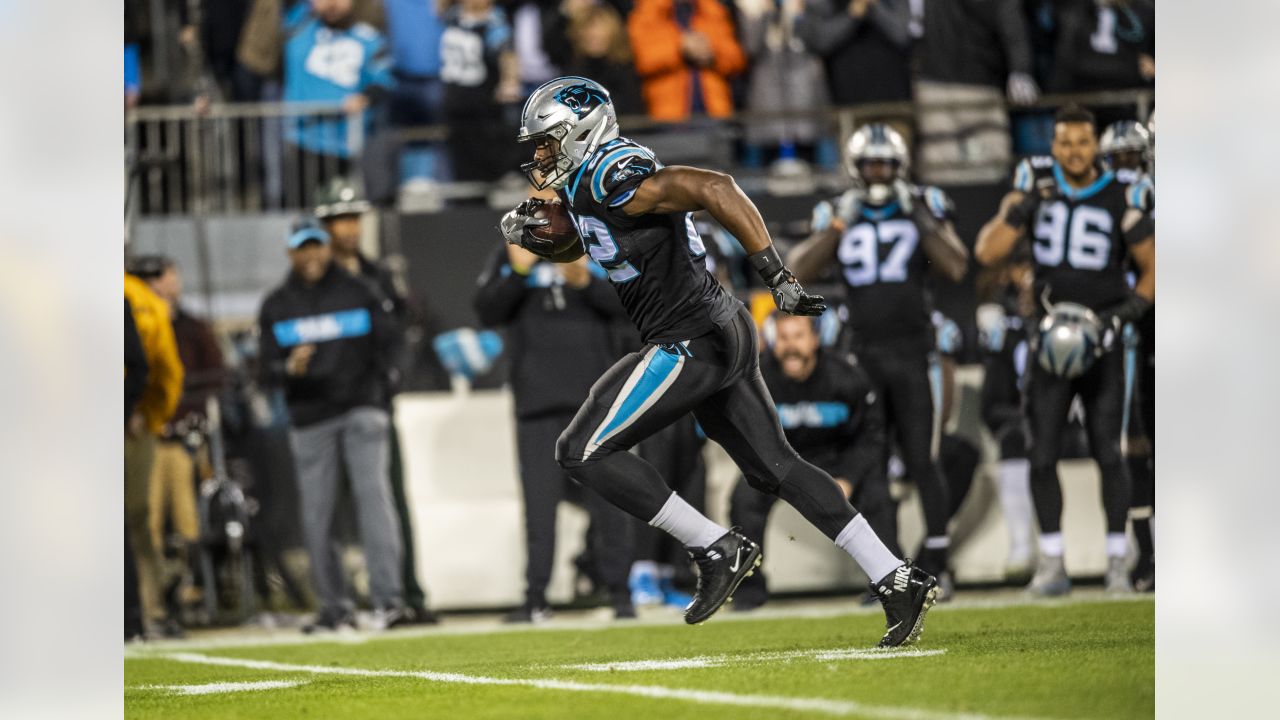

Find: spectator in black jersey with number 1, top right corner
<box><xmin>1051</xmin><ymin>0</ymin><xmax>1156</xmax><ymax>127</ymax></box>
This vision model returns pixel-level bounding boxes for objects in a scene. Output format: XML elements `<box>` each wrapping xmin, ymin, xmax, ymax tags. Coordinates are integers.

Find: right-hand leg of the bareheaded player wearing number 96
<box><xmin>1079</xmin><ymin>348</ymin><xmax>1133</xmax><ymax>592</ymax></box>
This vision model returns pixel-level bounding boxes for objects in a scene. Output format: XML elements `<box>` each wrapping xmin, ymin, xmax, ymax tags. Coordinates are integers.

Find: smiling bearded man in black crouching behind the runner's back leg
<box><xmin>730</xmin><ymin>313</ymin><xmax>896</xmax><ymax>610</ymax></box>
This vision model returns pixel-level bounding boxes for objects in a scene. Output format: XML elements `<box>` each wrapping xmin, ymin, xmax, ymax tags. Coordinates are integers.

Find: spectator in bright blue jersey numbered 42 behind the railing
<box><xmin>284</xmin><ymin>0</ymin><xmax>394</xmax><ymax>188</ymax></box>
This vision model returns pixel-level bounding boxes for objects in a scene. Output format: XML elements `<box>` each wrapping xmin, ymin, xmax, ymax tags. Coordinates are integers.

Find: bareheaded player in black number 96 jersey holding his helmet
<box><xmin>975</xmin><ymin>108</ymin><xmax>1156</xmax><ymax>594</ymax></box>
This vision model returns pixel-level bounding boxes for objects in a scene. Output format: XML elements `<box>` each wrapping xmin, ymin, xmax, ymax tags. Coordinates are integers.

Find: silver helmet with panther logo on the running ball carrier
<box><xmin>516</xmin><ymin>76</ymin><xmax>618</xmax><ymax>190</ymax></box>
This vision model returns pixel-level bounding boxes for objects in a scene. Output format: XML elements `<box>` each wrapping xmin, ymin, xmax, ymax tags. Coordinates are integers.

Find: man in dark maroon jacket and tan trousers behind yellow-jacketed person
<box><xmin>129</xmin><ymin>255</ymin><xmax>225</xmax><ymax>634</ymax></box>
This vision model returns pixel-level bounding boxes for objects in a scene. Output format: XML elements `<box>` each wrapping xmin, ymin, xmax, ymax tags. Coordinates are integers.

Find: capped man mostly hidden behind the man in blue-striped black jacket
<box><xmin>315</xmin><ymin>178</ymin><xmax>439</xmax><ymax>624</ymax></box>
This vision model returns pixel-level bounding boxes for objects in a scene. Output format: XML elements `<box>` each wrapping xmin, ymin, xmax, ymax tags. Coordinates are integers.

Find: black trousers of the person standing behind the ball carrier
<box><xmin>516</xmin><ymin>413</ymin><xmax>634</xmax><ymax>606</ymax></box>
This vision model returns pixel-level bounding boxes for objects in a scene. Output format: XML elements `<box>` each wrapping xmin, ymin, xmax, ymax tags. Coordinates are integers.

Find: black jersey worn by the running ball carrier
<box><xmin>559</xmin><ymin>137</ymin><xmax>740</xmax><ymax>345</ymax></box>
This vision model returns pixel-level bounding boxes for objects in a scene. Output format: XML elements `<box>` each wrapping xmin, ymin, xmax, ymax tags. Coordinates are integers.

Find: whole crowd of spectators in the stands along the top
<box><xmin>125</xmin><ymin>0</ymin><xmax>1155</xmax><ymax>195</ymax></box>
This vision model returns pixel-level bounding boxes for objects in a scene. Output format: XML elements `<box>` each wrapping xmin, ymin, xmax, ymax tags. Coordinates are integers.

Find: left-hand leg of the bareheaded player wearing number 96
<box><xmin>1027</xmin><ymin>363</ymin><xmax>1074</xmax><ymax>594</ymax></box>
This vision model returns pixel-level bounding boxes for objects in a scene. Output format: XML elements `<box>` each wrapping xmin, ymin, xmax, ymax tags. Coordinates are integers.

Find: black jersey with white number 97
<box><xmin>819</xmin><ymin>187</ymin><xmax>951</xmax><ymax>348</ymax></box>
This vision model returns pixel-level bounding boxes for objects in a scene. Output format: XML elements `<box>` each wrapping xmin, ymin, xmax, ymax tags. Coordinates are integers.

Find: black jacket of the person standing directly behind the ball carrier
<box><xmin>475</xmin><ymin>246</ymin><xmax>627</xmax><ymax>418</ymax></box>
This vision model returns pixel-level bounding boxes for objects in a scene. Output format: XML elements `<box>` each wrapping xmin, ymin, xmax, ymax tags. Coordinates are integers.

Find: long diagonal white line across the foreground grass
<box><xmin>160</xmin><ymin>652</ymin><xmax>1030</xmax><ymax>720</ymax></box>
